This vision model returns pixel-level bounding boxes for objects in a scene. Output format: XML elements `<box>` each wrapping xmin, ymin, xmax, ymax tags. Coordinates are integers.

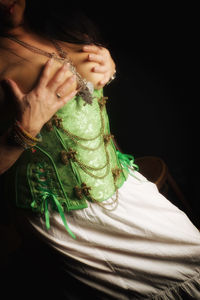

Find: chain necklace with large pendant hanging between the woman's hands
<box><xmin>6</xmin><ymin>36</ymin><xmax>94</xmax><ymax>104</ymax></box>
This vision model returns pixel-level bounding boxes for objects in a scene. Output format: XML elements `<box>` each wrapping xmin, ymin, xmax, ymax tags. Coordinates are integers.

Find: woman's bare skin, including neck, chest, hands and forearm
<box><xmin>0</xmin><ymin>0</ymin><xmax>115</xmax><ymax>174</ymax></box>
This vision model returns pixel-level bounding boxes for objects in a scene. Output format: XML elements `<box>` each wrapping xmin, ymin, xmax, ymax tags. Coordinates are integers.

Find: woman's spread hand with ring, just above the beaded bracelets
<box><xmin>6</xmin><ymin>59</ymin><xmax>77</xmax><ymax>136</ymax></box>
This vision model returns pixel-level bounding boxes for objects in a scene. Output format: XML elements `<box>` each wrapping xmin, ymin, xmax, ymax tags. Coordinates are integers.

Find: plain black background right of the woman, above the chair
<box><xmin>84</xmin><ymin>1</ymin><xmax>200</xmax><ymax>218</ymax></box>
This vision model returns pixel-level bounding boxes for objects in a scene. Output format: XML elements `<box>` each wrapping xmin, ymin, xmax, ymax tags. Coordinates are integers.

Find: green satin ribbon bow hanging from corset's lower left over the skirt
<box><xmin>42</xmin><ymin>190</ymin><xmax>76</xmax><ymax>239</ymax></box>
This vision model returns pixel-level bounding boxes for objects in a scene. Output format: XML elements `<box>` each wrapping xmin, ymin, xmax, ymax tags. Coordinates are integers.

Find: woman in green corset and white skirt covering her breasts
<box><xmin>0</xmin><ymin>0</ymin><xmax>200</xmax><ymax>299</ymax></box>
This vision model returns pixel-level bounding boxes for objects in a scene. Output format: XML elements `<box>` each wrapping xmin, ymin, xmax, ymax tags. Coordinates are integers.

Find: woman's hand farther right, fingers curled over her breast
<box><xmin>82</xmin><ymin>45</ymin><xmax>116</xmax><ymax>88</ymax></box>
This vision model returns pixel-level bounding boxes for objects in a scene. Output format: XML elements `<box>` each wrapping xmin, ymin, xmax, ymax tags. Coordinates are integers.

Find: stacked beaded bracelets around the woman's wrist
<box><xmin>8</xmin><ymin>121</ymin><xmax>42</xmax><ymax>149</ymax></box>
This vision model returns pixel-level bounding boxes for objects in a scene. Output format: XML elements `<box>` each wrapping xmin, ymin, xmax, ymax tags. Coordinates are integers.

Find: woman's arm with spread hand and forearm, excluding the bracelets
<box><xmin>0</xmin><ymin>59</ymin><xmax>77</xmax><ymax>174</ymax></box>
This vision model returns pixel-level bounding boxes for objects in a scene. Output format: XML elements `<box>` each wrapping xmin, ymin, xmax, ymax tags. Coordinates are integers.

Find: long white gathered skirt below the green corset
<box><xmin>28</xmin><ymin>172</ymin><xmax>200</xmax><ymax>300</ymax></box>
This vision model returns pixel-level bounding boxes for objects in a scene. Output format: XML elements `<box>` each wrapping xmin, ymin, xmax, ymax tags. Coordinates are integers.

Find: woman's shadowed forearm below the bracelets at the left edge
<box><xmin>0</xmin><ymin>131</ymin><xmax>24</xmax><ymax>175</ymax></box>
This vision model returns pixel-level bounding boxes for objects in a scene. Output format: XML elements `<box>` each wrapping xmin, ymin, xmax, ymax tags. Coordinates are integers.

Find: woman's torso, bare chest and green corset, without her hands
<box><xmin>0</xmin><ymin>35</ymin><xmax>127</xmax><ymax>230</ymax></box>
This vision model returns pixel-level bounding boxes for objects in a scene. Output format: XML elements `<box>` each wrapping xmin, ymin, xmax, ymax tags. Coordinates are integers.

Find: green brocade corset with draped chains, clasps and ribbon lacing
<box><xmin>2</xmin><ymin>90</ymin><xmax>138</xmax><ymax>237</ymax></box>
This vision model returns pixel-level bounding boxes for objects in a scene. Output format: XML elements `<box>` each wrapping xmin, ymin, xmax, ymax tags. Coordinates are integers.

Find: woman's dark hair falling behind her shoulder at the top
<box><xmin>24</xmin><ymin>0</ymin><xmax>104</xmax><ymax>45</ymax></box>
